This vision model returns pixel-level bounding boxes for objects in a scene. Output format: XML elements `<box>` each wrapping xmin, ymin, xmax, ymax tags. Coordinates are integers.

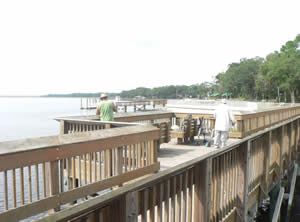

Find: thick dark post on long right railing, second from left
<box><xmin>194</xmin><ymin>158</ymin><xmax>212</xmax><ymax>222</ymax></box>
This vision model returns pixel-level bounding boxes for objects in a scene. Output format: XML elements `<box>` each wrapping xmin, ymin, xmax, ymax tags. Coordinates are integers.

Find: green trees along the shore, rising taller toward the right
<box><xmin>120</xmin><ymin>34</ymin><xmax>300</xmax><ymax>102</ymax></box>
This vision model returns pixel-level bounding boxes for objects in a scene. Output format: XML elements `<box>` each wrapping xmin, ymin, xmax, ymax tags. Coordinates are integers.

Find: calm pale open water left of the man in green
<box><xmin>0</xmin><ymin>98</ymin><xmax>95</xmax><ymax>142</ymax></box>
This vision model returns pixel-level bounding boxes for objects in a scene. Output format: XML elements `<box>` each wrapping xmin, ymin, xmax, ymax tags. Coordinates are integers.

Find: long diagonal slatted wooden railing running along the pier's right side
<box><xmin>38</xmin><ymin>117</ymin><xmax>300</xmax><ymax>222</ymax></box>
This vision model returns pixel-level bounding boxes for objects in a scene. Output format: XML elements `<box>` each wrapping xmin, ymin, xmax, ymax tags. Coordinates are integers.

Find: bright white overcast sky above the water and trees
<box><xmin>0</xmin><ymin>0</ymin><xmax>300</xmax><ymax>95</ymax></box>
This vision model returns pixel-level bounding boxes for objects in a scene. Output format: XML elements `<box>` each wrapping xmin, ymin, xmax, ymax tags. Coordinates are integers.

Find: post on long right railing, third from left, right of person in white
<box><xmin>237</xmin><ymin>140</ymin><xmax>251</xmax><ymax>222</ymax></box>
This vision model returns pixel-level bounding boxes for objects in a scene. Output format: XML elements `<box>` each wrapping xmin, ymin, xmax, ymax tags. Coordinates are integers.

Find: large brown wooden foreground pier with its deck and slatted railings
<box><xmin>0</xmin><ymin>106</ymin><xmax>300</xmax><ymax>222</ymax></box>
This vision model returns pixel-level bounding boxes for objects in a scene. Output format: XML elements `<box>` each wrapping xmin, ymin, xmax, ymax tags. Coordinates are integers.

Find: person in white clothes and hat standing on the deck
<box><xmin>214</xmin><ymin>99</ymin><xmax>235</xmax><ymax>148</ymax></box>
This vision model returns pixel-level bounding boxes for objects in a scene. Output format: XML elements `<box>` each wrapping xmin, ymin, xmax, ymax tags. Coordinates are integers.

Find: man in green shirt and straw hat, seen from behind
<box><xmin>96</xmin><ymin>94</ymin><xmax>117</xmax><ymax>121</ymax></box>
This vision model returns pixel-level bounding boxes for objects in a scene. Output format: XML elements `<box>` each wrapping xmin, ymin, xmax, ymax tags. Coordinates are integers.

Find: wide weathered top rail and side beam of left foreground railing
<box><xmin>0</xmin><ymin>126</ymin><xmax>159</xmax><ymax>171</ymax></box>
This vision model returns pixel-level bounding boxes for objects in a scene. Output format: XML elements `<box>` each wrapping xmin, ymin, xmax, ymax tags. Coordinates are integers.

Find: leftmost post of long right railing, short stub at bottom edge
<box><xmin>126</xmin><ymin>191</ymin><xmax>139</xmax><ymax>222</ymax></box>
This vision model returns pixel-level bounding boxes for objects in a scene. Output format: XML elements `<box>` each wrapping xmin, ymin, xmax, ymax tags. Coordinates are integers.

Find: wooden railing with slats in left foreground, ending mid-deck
<box><xmin>0</xmin><ymin>126</ymin><xmax>159</xmax><ymax>222</ymax></box>
